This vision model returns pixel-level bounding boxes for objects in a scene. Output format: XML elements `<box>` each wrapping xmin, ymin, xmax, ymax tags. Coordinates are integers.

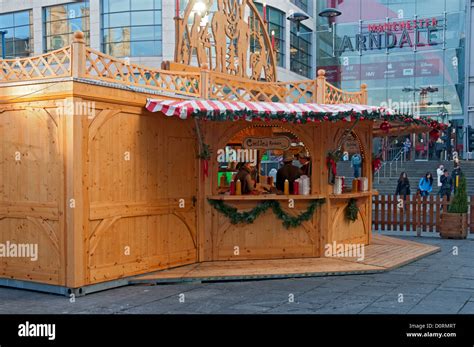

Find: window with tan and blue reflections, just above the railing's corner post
<box><xmin>44</xmin><ymin>1</ymin><xmax>90</xmax><ymax>52</ymax></box>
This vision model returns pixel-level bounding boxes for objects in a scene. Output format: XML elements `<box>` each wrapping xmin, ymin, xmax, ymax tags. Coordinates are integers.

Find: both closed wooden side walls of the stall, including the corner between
<box><xmin>0</xmin><ymin>83</ymin><xmax>199</xmax><ymax>287</ymax></box>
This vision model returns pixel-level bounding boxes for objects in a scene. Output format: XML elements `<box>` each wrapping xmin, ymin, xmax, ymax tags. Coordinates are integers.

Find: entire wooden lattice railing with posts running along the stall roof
<box><xmin>0</xmin><ymin>32</ymin><xmax>367</xmax><ymax>104</ymax></box>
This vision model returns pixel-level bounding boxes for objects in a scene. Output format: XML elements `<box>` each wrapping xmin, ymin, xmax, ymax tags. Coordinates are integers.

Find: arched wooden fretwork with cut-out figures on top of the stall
<box><xmin>175</xmin><ymin>0</ymin><xmax>276</xmax><ymax>81</ymax></box>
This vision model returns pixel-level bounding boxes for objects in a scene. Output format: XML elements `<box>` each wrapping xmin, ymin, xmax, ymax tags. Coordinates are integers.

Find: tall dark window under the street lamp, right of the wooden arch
<box><xmin>290</xmin><ymin>22</ymin><xmax>313</xmax><ymax>78</ymax></box>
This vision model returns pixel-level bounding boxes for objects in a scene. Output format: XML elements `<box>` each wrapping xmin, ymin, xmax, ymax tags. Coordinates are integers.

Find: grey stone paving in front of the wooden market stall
<box><xmin>0</xmin><ymin>234</ymin><xmax>474</xmax><ymax>314</ymax></box>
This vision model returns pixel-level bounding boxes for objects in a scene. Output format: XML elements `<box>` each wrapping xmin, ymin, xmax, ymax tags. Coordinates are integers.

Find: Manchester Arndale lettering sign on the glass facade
<box><xmin>336</xmin><ymin>18</ymin><xmax>442</xmax><ymax>54</ymax></box>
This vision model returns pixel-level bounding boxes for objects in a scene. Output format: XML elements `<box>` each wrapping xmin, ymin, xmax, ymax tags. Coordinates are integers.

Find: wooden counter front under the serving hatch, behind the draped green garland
<box><xmin>206</xmin><ymin>194</ymin><xmax>326</xmax><ymax>260</ymax></box>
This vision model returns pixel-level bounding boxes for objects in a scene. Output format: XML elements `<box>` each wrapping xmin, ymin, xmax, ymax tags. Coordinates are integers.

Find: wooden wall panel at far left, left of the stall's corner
<box><xmin>0</xmin><ymin>103</ymin><xmax>65</xmax><ymax>285</ymax></box>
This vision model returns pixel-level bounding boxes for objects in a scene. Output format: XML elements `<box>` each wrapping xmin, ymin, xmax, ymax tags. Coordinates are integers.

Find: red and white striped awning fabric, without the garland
<box><xmin>146</xmin><ymin>99</ymin><xmax>393</xmax><ymax>120</ymax></box>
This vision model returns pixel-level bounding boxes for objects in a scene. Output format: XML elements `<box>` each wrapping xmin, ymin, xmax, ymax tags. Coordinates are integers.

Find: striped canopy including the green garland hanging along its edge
<box><xmin>146</xmin><ymin>99</ymin><xmax>446</xmax><ymax>132</ymax></box>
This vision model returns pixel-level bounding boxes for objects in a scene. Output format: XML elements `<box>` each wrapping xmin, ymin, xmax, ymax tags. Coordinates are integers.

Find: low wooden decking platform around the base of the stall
<box><xmin>130</xmin><ymin>234</ymin><xmax>440</xmax><ymax>284</ymax></box>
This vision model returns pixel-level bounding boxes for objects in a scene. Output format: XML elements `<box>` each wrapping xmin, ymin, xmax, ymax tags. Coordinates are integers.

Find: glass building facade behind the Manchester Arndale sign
<box><xmin>317</xmin><ymin>0</ymin><xmax>467</xmax><ymax>155</ymax></box>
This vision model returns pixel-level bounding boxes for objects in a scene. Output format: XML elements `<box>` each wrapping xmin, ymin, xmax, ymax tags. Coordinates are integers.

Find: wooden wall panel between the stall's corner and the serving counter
<box><xmin>86</xmin><ymin>104</ymin><xmax>198</xmax><ymax>283</ymax></box>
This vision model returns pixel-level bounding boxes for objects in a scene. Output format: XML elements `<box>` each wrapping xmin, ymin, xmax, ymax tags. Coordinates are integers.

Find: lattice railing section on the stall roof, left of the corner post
<box><xmin>0</xmin><ymin>46</ymin><xmax>72</xmax><ymax>83</ymax></box>
